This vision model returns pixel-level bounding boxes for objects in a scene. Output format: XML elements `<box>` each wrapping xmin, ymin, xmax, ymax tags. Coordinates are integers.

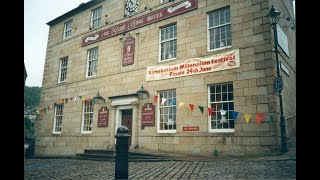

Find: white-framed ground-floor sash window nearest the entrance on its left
<box><xmin>81</xmin><ymin>101</ymin><xmax>94</xmax><ymax>134</ymax></box>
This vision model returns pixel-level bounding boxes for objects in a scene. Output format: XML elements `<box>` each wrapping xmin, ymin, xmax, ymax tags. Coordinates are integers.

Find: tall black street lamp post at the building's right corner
<box><xmin>267</xmin><ymin>6</ymin><xmax>288</xmax><ymax>153</ymax></box>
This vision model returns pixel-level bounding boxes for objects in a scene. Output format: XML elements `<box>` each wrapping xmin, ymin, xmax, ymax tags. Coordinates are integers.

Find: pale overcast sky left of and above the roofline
<box><xmin>24</xmin><ymin>0</ymin><xmax>296</xmax><ymax>87</ymax></box>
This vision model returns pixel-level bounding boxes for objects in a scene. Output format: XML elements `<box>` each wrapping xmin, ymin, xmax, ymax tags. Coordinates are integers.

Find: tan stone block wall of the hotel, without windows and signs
<box><xmin>35</xmin><ymin>0</ymin><xmax>296</xmax><ymax>156</ymax></box>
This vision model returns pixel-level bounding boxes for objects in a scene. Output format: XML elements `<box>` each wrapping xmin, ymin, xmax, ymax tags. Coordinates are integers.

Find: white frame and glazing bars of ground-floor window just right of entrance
<box><xmin>157</xmin><ymin>89</ymin><xmax>177</xmax><ymax>133</ymax></box>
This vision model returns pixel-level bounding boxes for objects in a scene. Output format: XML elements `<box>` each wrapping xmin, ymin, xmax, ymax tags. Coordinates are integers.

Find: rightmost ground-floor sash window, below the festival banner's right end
<box><xmin>208</xmin><ymin>83</ymin><xmax>234</xmax><ymax>132</ymax></box>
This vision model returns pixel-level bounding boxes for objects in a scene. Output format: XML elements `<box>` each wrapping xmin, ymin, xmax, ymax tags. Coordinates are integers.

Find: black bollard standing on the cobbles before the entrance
<box><xmin>115</xmin><ymin>126</ymin><xmax>130</xmax><ymax>179</ymax></box>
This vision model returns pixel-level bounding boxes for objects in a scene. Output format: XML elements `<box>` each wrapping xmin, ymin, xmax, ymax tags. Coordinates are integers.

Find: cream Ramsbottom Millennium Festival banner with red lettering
<box><xmin>146</xmin><ymin>49</ymin><xmax>240</xmax><ymax>81</ymax></box>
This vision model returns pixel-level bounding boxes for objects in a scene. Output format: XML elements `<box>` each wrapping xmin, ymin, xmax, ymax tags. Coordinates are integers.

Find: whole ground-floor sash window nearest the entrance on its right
<box><xmin>157</xmin><ymin>90</ymin><xmax>176</xmax><ymax>133</ymax></box>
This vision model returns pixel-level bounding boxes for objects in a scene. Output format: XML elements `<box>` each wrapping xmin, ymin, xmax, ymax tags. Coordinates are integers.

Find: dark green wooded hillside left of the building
<box><xmin>24</xmin><ymin>86</ymin><xmax>41</xmax><ymax>109</ymax></box>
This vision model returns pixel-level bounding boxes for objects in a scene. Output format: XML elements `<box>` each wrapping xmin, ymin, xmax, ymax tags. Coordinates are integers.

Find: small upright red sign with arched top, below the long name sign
<box><xmin>122</xmin><ymin>36</ymin><xmax>134</xmax><ymax>66</ymax></box>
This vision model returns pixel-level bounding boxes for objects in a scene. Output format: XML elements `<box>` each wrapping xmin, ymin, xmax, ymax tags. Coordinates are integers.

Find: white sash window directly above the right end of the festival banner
<box><xmin>208</xmin><ymin>7</ymin><xmax>231</xmax><ymax>51</ymax></box>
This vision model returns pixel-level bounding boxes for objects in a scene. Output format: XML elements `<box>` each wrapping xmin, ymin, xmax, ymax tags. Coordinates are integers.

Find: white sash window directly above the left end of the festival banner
<box><xmin>160</xmin><ymin>24</ymin><xmax>177</xmax><ymax>61</ymax></box>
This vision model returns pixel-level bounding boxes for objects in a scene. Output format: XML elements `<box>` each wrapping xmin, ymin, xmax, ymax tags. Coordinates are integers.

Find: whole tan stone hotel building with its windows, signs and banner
<box><xmin>35</xmin><ymin>0</ymin><xmax>296</xmax><ymax>156</ymax></box>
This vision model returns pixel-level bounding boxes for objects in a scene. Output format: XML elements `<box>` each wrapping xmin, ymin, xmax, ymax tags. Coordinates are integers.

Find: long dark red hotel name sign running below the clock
<box><xmin>81</xmin><ymin>0</ymin><xmax>197</xmax><ymax>46</ymax></box>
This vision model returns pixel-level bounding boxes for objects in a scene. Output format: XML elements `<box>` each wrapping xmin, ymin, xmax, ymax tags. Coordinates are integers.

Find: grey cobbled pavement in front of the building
<box><xmin>24</xmin><ymin>137</ymin><xmax>296</xmax><ymax>180</ymax></box>
